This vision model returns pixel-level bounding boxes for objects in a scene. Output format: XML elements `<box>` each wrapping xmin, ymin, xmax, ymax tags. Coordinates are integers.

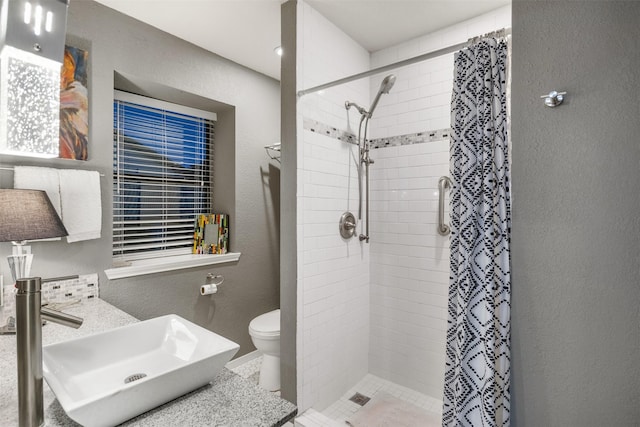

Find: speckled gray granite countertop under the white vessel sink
<box><xmin>0</xmin><ymin>299</ymin><xmax>297</xmax><ymax>427</ymax></box>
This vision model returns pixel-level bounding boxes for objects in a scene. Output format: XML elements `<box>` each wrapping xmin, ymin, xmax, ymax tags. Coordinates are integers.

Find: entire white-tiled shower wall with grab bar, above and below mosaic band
<box><xmin>369</xmin><ymin>6</ymin><xmax>511</xmax><ymax>399</ymax></box>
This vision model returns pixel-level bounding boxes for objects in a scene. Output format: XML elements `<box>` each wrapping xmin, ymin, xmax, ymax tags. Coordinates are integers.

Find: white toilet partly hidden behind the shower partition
<box><xmin>249</xmin><ymin>309</ymin><xmax>280</xmax><ymax>391</ymax></box>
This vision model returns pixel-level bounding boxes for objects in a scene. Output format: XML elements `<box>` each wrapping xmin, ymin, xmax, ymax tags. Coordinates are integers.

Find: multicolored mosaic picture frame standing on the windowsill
<box><xmin>193</xmin><ymin>214</ymin><xmax>229</xmax><ymax>254</ymax></box>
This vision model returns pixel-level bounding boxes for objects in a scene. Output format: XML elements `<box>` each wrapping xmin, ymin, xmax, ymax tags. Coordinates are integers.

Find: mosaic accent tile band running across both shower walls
<box><xmin>303</xmin><ymin>118</ymin><xmax>451</xmax><ymax>148</ymax></box>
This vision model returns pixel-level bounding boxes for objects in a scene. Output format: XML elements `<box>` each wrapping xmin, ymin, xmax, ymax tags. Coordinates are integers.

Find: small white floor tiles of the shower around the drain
<box><xmin>322</xmin><ymin>374</ymin><xmax>442</xmax><ymax>422</ymax></box>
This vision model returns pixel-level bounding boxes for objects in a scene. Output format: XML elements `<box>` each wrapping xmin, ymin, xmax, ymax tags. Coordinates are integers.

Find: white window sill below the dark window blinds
<box><xmin>104</xmin><ymin>252</ymin><xmax>241</xmax><ymax>280</ymax></box>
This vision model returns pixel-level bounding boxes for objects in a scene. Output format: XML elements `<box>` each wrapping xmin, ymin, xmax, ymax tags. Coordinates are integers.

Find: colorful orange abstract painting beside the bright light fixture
<box><xmin>59</xmin><ymin>46</ymin><xmax>89</xmax><ymax>160</ymax></box>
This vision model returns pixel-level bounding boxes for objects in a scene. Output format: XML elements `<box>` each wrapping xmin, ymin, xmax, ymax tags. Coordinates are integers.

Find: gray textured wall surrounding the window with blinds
<box><xmin>0</xmin><ymin>1</ymin><xmax>280</xmax><ymax>355</ymax></box>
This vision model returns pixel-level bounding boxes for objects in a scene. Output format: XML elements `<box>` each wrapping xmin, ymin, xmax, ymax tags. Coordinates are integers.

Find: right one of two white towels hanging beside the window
<box><xmin>58</xmin><ymin>169</ymin><xmax>102</xmax><ymax>243</ymax></box>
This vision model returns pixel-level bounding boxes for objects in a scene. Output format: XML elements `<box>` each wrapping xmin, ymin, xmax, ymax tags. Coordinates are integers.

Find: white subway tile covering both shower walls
<box><xmin>297</xmin><ymin>1</ymin><xmax>511</xmax><ymax>412</ymax></box>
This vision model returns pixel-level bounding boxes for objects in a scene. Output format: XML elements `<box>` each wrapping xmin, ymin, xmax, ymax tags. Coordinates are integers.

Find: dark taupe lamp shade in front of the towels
<box><xmin>0</xmin><ymin>189</ymin><xmax>68</xmax><ymax>242</ymax></box>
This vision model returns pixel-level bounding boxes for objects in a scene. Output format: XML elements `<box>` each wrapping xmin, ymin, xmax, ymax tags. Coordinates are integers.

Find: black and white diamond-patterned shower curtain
<box><xmin>442</xmin><ymin>38</ymin><xmax>511</xmax><ymax>427</ymax></box>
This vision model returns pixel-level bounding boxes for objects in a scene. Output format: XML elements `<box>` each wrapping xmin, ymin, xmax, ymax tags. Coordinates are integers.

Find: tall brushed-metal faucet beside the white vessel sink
<box><xmin>16</xmin><ymin>277</ymin><xmax>83</xmax><ymax>427</ymax></box>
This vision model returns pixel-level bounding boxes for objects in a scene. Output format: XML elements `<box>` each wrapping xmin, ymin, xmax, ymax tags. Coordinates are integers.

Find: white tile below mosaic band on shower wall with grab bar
<box><xmin>369</xmin><ymin>139</ymin><xmax>449</xmax><ymax>399</ymax></box>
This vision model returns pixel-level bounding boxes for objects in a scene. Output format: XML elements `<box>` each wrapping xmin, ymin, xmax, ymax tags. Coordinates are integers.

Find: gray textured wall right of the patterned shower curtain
<box><xmin>512</xmin><ymin>0</ymin><xmax>640</xmax><ymax>427</ymax></box>
